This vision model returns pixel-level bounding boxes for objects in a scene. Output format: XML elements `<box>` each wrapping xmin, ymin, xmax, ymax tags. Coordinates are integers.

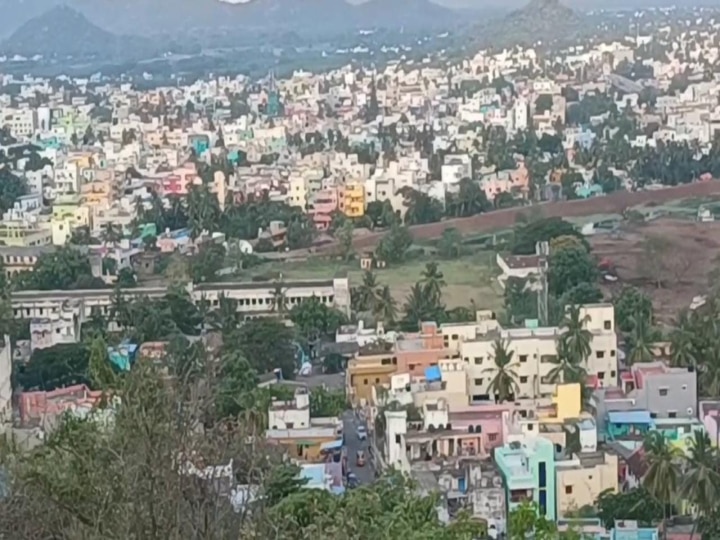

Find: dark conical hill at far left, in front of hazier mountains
<box><xmin>0</xmin><ymin>6</ymin><xmax>149</xmax><ymax>59</ymax></box>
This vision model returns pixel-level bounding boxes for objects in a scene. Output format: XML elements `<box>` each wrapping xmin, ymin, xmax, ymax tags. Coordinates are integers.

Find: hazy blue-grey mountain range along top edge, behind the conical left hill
<box><xmin>0</xmin><ymin>0</ymin><xmax>462</xmax><ymax>41</ymax></box>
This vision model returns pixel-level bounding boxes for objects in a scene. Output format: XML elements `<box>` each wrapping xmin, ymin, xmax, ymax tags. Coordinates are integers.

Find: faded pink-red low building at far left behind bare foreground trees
<box><xmin>19</xmin><ymin>384</ymin><xmax>102</xmax><ymax>425</ymax></box>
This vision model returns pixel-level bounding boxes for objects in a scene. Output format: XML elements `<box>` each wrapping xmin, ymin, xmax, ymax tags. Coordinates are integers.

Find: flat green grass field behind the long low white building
<box><xmin>245</xmin><ymin>251</ymin><xmax>502</xmax><ymax>310</ymax></box>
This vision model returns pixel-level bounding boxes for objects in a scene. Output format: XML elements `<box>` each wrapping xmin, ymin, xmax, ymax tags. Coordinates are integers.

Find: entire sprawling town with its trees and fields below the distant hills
<box><xmin>0</xmin><ymin>5</ymin><xmax>720</xmax><ymax>540</ymax></box>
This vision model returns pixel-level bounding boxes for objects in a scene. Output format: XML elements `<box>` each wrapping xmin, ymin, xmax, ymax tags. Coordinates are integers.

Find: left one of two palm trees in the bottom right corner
<box><xmin>642</xmin><ymin>431</ymin><xmax>682</xmax><ymax>538</ymax></box>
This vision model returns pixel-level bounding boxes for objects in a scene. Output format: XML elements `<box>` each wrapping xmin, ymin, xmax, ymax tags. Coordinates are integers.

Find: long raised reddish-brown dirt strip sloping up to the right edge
<box><xmin>344</xmin><ymin>180</ymin><xmax>720</xmax><ymax>251</ymax></box>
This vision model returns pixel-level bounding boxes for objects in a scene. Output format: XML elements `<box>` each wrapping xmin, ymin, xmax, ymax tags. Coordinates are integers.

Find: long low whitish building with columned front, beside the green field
<box><xmin>12</xmin><ymin>277</ymin><xmax>350</xmax><ymax>320</ymax></box>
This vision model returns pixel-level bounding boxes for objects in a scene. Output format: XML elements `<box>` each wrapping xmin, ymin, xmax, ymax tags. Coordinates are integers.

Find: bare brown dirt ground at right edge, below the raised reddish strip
<box><xmin>589</xmin><ymin>218</ymin><xmax>720</xmax><ymax>324</ymax></box>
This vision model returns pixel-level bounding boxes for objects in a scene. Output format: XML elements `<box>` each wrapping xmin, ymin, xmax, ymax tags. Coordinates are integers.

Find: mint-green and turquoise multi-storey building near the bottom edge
<box><xmin>495</xmin><ymin>437</ymin><xmax>557</xmax><ymax>521</ymax></box>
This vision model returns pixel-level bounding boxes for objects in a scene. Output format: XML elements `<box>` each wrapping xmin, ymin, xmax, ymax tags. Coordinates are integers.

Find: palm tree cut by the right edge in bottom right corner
<box><xmin>680</xmin><ymin>431</ymin><xmax>720</xmax><ymax>540</ymax></box>
